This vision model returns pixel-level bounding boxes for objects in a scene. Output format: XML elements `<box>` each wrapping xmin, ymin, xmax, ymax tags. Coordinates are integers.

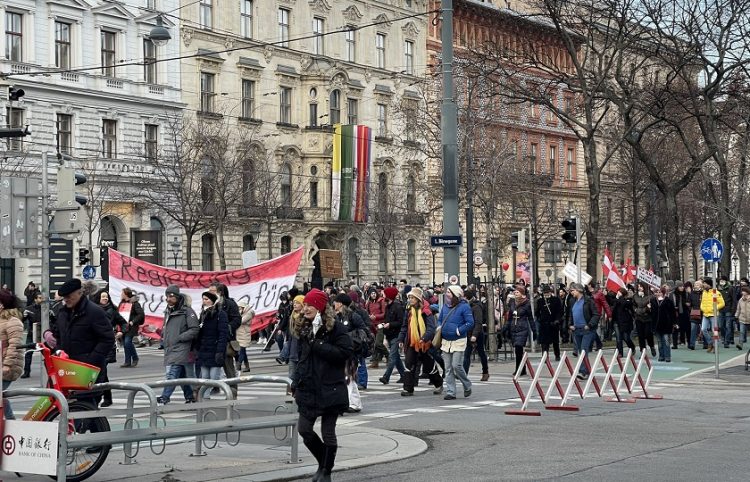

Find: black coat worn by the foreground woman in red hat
<box><xmin>292</xmin><ymin>319</ymin><xmax>354</xmax><ymax>419</ymax></box>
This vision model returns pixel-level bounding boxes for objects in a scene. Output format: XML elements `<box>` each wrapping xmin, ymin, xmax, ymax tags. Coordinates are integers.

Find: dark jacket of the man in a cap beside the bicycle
<box><xmin>50</xmin><ymin>297</ymin><xmax>115</xmax><ymax>370</ymax></box>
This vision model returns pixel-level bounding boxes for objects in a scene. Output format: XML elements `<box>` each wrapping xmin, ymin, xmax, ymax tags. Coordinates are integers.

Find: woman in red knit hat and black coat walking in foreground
<box><xmin>292</xmin><ymin>289</ymin><xmax>353</xmax><ymax>481</ymax></box>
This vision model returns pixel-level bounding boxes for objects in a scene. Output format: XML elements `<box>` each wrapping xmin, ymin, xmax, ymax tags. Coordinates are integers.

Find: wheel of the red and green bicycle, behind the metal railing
<box><xmin>44</xmin><ymin>400</ymin><xmax>112</xmax><ymax>482</ymax></box>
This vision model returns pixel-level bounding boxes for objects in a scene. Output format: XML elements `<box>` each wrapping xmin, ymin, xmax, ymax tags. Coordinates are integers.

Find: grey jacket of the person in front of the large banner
<box><xmin>161</xmin><ymin>295</ymin><xmax>200</xmax><ymax>365</ymax></box>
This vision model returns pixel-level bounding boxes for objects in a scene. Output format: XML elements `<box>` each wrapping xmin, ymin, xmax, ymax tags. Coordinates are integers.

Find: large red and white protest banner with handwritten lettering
<box><xmin>109</xmin><ymin>247</ymin><xmax>303</xmax><ymax>339</ymax></box>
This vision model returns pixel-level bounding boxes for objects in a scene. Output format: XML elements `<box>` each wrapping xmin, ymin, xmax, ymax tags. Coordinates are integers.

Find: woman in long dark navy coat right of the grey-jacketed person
<box><xmin>197</xmin><ymin>291</ymin><xmax>229</xmax><ymax>399</ymax></box>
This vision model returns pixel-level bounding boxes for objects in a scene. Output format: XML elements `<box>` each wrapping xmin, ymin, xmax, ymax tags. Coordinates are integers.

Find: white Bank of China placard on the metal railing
<box><xmin>0</xmin><ymin>420</ymin><xmax>58</xmax><ymax>475</ymax></box>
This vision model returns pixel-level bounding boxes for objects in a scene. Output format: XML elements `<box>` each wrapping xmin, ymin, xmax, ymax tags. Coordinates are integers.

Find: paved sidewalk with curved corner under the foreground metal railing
<box><xmin>0</xmin><ymin>425</ymin><xmax>427</xmax><ymax>482</ymax></box>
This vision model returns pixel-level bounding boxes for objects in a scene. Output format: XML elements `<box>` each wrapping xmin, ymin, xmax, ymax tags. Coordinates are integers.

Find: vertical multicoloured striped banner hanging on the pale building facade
<box><xmin>331</xmin><ymin>124</ymin><xmax>372</xmax><ymax>223</ymax></box>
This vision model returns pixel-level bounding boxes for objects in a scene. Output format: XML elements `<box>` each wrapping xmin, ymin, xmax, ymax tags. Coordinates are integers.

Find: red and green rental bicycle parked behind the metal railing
<box><xmin>14</xmin><ymin>343</ymin><xmax>112</xmax><ymax>482</ymax></box>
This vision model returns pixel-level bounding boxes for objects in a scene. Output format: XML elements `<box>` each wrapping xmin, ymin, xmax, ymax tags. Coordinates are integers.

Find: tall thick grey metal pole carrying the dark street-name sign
<box><xmin>440</xmin><ymin>0</ymin><xmax>458</xmax><ymax>276</ymax></box>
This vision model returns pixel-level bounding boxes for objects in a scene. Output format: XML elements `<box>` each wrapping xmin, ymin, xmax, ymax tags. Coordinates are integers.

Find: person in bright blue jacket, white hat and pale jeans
<box><xmin>437</xmin><ymin>285</ymin><xmax>474</xmax><ymax>400</ymax></box>
